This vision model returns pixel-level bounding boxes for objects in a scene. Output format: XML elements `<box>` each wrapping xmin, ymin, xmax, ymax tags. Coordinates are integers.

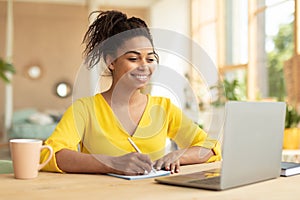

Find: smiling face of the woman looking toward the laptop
<box><xmin>110</xmin><ymin>36</ymin><xmax>158</xmax><ymax>88</ymax></box>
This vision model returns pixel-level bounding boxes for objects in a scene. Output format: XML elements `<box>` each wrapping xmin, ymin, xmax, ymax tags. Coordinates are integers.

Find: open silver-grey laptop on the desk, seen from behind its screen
<box><xmin>155</xmin><ymin>101</ymin><xmax>286</xmax><ymax>190</ymax></box>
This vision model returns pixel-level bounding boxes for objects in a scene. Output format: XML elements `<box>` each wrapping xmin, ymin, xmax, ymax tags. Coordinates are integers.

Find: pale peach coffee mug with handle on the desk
<box><xmin>9</xmin><ymin>139</ymin><xmax>53</xmax><ymax>179</ymax></box>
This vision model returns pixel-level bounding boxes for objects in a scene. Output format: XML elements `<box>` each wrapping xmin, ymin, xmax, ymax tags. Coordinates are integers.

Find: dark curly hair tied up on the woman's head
<box><xmin>83</xmin><ymin>10</ymin><xmax>153</xmax><ymax>69</ymax></box>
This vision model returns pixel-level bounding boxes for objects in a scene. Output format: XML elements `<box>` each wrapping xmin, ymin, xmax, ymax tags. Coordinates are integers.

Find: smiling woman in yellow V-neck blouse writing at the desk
<box><xmin>42</xmin><ymin>11</ymin><xmax>221</xmax><ymax>175</ymax></box>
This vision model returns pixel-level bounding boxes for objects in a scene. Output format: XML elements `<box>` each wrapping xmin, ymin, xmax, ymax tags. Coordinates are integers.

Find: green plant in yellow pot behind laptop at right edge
<box><xmin>283</xmin><ymin>105</ymin><xmax>300</xmax><ymax>149</ymax></box>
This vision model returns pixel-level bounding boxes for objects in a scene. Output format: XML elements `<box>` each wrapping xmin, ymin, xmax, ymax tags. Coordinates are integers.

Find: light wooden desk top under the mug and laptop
<box><xmin>0</xmin><ymin>163</ymin><xmax>300</xmax><ymax>200</ymax></box>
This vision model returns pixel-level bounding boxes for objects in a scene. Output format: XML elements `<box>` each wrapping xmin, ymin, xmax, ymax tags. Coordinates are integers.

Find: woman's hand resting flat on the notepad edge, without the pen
<box><xmin>153</xmin><ymin>151</ymin><xmax>182</xmax><ymax>174</ymax></box>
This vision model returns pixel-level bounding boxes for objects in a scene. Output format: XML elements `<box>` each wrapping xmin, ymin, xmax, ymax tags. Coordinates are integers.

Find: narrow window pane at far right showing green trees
<box><xmin>265</xmin><ymin>0</ymin><xmax>295</xmax><ymax>100</ymax></box>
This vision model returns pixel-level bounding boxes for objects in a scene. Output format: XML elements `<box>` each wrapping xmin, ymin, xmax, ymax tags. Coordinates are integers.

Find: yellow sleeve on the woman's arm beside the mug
<box><xmin>41</xmin><ymin>100</ymin><xmax>86</xmax><ymax>172</ymax></box>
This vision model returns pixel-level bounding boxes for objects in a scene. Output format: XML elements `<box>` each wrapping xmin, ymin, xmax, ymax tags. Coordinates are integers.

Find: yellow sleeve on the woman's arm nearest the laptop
<box><xmin>169</xmin><ymin>102</ymin><xmax>221</xmax><ymax>162</ymax></box>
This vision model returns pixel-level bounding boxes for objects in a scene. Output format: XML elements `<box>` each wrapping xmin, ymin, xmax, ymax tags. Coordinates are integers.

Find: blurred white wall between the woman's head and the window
<box><xmin>149</xmin><ymin>0</ymin><xmax>198</xmax><ymax>121</ymax></box>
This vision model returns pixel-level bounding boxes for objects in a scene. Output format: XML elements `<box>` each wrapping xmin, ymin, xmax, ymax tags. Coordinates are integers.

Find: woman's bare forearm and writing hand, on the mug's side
<box><xmin>55</xmin><ymin>149</ymin><xmax>152</xmax><ymax>175</ymax></box>
